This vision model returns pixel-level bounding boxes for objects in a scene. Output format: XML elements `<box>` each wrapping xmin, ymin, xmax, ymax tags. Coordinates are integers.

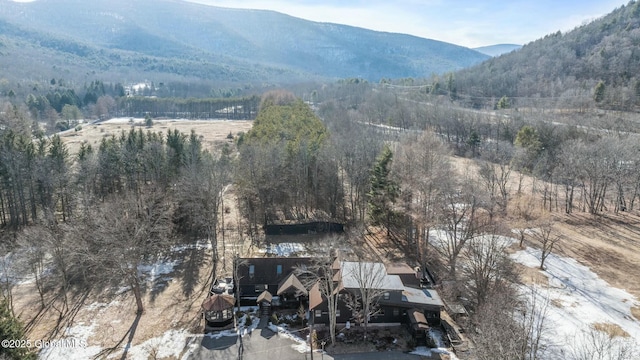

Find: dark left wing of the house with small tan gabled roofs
<box><xmin>235</xmin><ymin>257</ymin><xmax>311</xmax><ymax>312</ymax></box>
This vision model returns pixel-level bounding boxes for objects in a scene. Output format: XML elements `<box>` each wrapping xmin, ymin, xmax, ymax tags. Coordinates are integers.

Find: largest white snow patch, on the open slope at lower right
<box><xmin>511</xmin><ymin>247</ymin><xmax>640</xmax><ymax>359</ymax></box>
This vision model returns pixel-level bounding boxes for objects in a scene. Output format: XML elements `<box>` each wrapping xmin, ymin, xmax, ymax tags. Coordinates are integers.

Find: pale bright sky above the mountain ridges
<box><xmin>189</xmin><ymin>0</ymin><xmax>628</xmax><ymax>47</ymax></box>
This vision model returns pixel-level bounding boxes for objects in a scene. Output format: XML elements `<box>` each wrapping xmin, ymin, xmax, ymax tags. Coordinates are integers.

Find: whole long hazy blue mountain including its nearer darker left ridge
<box><xmin>0</xmin><ymin>0</ymin><xmax>487</xmax><ymax>82</ymax></box>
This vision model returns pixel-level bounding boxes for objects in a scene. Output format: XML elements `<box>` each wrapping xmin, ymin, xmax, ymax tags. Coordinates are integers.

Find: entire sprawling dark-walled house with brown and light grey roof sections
<box><xmin>234</xmin><ymin>257</ymin><xmax>444</xmax><ymax>336</ymax></box>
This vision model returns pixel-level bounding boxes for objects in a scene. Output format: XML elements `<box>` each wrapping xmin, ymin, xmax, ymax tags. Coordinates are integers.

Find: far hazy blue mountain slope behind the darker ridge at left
<box><xmin>0</xmin><ymin>0</ymin><xmax>487</xmax><ymax>80</ymax></box>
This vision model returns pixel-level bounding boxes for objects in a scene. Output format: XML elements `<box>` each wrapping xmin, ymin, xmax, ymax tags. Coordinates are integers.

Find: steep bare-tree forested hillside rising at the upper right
<box><xmin>456</xmin><ymin>1</ymin><xmax>640</xmax><ymax>110</ymax></box>
